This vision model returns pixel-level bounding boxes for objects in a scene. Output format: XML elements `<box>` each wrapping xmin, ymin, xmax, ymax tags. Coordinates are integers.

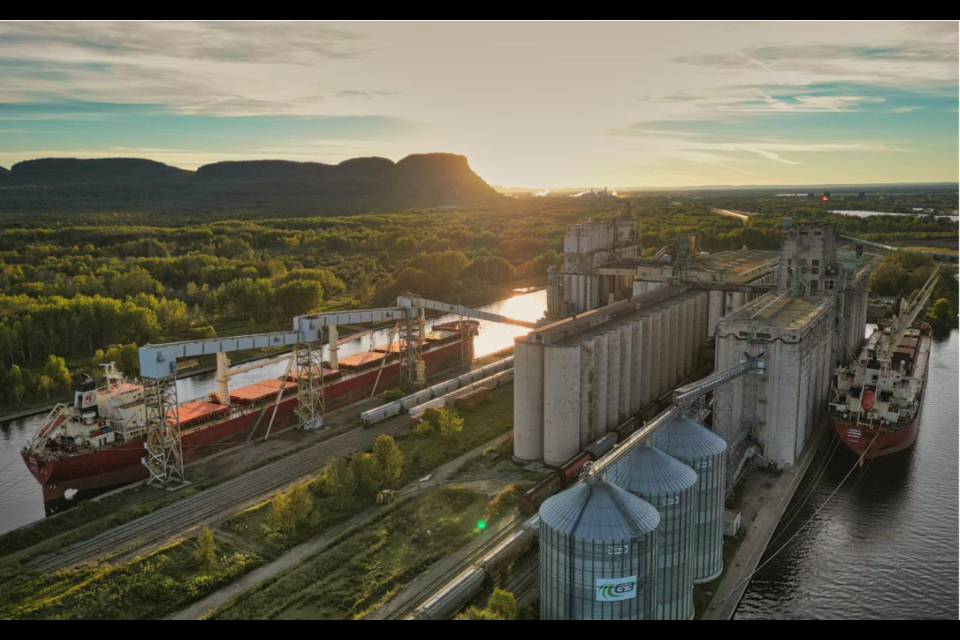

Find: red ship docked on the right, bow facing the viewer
<box><xmin>830</xmin><ymin>271</ymin><xmax>938</xmax><ymax>460</ymax></box>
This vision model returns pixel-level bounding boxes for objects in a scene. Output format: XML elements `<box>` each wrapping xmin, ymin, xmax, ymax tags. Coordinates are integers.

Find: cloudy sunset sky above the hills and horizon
<box><xmin>0</xmin><ymin>21</ymin><xmax>958</xmax><ymax>189</ymax></box>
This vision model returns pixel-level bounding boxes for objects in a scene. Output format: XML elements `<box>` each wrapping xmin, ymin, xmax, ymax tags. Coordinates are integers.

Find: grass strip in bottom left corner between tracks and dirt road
<box><xmin>0</xmin><ymin>539</ymin><xmax>263</xmax><ymax>620</ymax></box>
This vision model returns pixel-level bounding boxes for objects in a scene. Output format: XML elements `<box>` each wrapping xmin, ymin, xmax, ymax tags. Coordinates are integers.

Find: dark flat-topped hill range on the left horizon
<box><xmin>0</xmin><ymin>153</ymin><xmax>500</xmax><ymax>214</ymax></box>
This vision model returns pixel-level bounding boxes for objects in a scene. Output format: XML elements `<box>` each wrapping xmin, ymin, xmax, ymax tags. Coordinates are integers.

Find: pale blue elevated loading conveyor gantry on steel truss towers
<box><xmin>140</xmin><ymin>294</ymin><xmax>536</xmax><ymax>486</ymax></box>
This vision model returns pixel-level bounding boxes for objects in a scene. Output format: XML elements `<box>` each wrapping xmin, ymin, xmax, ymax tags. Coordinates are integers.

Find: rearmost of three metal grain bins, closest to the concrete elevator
<box><xmin>652</xmin><ymin>417</ymin><xmax>727</xmax><ymax>584</ymax></box>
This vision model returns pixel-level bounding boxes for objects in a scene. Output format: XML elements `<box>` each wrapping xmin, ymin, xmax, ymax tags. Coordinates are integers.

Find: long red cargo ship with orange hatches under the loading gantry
<box><xmin>22</xmin><ymin>320</ymin><xmax>479</xmax><ymax>502</ymax></box>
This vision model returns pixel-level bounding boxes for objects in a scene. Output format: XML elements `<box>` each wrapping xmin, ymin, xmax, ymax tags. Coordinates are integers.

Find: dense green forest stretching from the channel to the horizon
<box><xmin>0</xmin><ymin>189</ymin><xmax>957</xmax><ymax>409</ymax></box>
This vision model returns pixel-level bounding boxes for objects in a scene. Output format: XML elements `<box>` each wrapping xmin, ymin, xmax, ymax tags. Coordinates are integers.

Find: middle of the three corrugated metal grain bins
<box><xmin>606</xmin><ymin>445</ymin><xmax>697</xmax><ymax>620</ymax></box>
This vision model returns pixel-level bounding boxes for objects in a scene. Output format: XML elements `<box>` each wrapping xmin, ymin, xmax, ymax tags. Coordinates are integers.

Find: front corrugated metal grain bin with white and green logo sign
<box><xmin>540</xmin><ymin>479</ymin><xmax>660</xmax><ymax>620</ymax></box>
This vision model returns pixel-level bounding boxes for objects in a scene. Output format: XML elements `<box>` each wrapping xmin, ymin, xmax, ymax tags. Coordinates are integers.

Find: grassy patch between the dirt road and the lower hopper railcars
<box><xmin>210</xmin><ymin>488</ymin><xmax>498</xmax><ymax>620</ymax></box>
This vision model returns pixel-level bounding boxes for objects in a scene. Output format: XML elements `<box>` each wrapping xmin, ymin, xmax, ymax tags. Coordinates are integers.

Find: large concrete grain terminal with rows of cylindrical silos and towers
<box><xmin>514</xmin><ymin>220</ymin><xmax>876</xmax><ymax>468</ymax></box>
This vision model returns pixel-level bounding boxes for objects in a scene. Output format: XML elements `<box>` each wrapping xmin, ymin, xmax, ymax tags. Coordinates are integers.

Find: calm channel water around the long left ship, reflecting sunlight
<box><xmin>0</xmin><ymin>289</ymin><xmax>547</xmax><ymax>533</ymax></box>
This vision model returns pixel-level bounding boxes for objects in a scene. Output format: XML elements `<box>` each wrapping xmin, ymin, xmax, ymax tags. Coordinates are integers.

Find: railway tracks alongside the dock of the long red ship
<box><xmin>29</xmin><ymin>416</ymin><xmax>410</xmax><ymax>572</ymax></box>
